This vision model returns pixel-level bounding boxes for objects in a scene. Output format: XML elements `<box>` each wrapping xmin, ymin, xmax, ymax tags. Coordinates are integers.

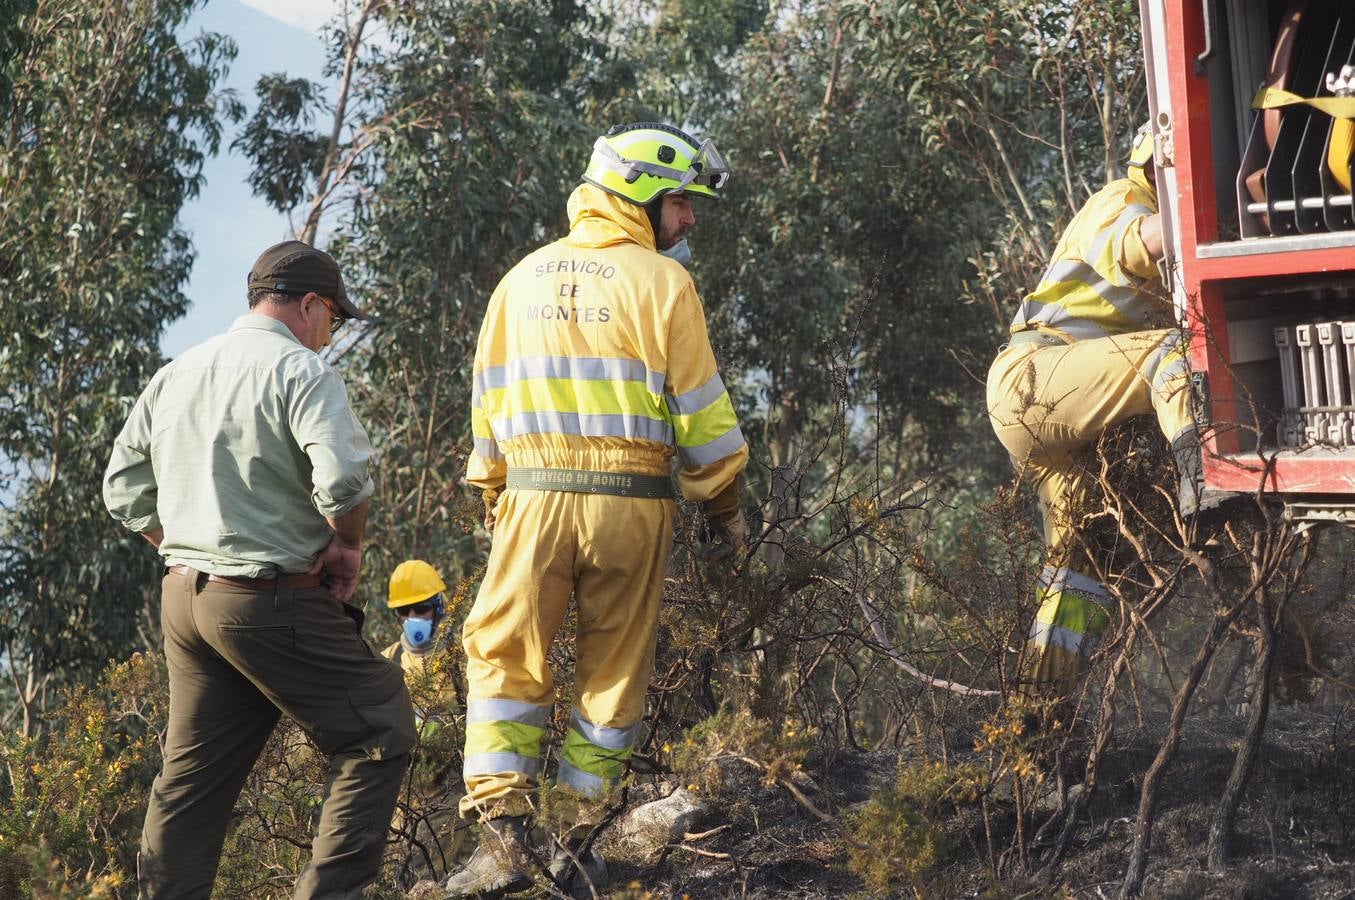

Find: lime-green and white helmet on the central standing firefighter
<box><xmin>584</xmin><ymin>122</ymin><xmax>729</xmax><ymax>206</ymax></box>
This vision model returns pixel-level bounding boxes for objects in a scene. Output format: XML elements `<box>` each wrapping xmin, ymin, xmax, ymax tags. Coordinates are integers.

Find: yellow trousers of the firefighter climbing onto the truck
<box><xmin>988</xmin><ymin>329</ymin><xmax>1195</xmax><ymax>695</ymax></box>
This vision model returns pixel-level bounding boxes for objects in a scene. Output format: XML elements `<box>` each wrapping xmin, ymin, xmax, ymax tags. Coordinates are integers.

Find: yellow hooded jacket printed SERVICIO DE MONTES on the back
<box><xmin>466</xmin><ymin>178</ymin><xmax>748</xmax><ymax>500</ymax></box>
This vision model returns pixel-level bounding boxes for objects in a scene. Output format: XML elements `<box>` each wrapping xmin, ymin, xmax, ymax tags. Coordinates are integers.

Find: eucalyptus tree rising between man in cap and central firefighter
<box><xmin>231</xmin><ymin>0</ymin><xmax>633</xmax><ymax>631</ymax></box>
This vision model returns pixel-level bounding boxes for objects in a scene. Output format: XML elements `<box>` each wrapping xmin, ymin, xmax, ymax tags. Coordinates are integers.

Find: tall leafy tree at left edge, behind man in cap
<box><xmin>0</xmin><ymin>0</ymin><xmax>234</xmax><ymax>731</ymax></box>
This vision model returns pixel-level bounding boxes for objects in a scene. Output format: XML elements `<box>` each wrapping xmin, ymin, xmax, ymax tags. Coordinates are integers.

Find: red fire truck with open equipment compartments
<box><xmin>1140</xmin><ymin>0</ymin><xmax>1355</xmax><ymax>523</ymax></box>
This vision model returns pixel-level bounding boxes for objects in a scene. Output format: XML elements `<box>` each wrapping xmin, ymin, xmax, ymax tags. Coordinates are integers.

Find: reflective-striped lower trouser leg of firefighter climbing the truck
<box><xmin>1027</xmin><ymin>567</ymin><xmax>1110</xmax><ymax>695</ymax></box>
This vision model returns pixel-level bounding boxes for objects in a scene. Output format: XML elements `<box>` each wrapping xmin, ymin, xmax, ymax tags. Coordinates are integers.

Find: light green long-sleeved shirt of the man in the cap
<box><xmin>104</xmin><ymin>304</ymin><xmax>373</xmax><ymax>580</ymax></box>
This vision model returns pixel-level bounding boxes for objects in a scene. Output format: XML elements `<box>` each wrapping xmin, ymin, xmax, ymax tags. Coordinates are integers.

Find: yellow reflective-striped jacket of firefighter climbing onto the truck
<box><xmin>1011</xmin><ymin>178</ymin><xmax>1172</xmax><ymax>340</ymax></box>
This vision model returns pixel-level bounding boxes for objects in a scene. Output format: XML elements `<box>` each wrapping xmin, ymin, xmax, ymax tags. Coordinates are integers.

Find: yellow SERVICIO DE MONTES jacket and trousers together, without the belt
<box><xmin>462</xmin><ymin>184</ymin><xmax>748</xmax><ymax>817</ymax></box>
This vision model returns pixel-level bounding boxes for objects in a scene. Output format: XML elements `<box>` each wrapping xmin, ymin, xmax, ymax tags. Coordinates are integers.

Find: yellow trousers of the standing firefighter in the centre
<box><xmin>461</xmin><ymin>491</ymin><xmax>675</xmax><ymax>816</ymax></box>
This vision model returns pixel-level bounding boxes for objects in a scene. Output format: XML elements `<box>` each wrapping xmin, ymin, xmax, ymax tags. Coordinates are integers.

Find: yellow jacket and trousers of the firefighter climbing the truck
<box><xmin>988</xmin><ymin>168</ymin><xmax>1195</xmax><ymax>695</ymax></box>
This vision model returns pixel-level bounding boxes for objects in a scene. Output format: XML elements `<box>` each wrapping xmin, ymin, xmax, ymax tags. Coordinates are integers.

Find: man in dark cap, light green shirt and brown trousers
<box><xmin>103</xmin><ymin>241</ymin><xmax>415</xmax><ymax>900</ymax></box>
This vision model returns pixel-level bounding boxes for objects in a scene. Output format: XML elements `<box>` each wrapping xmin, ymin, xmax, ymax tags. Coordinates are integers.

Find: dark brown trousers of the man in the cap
<box><xmin>138</xmin><ymin>573</ymin><xmax>415</xmax><ymax>900</ymax></box>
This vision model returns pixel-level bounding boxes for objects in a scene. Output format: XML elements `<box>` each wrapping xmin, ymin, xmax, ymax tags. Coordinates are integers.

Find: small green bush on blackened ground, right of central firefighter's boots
<box><xmin>847</xmin><ymin>759</ymin><xmax>978</xmax><ymax>896</ymax></box>
